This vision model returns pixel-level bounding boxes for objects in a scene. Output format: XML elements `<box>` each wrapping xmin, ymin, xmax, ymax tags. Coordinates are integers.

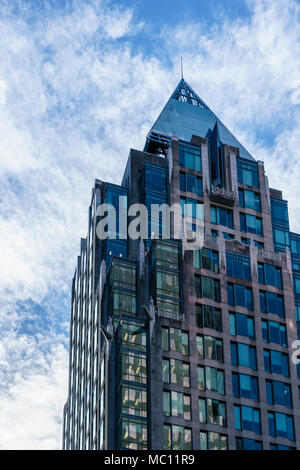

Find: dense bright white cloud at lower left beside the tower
<box><xmin>0</xmin><ymin>342</ymin><xmax>68</xmax><ymax>450</ymax></box>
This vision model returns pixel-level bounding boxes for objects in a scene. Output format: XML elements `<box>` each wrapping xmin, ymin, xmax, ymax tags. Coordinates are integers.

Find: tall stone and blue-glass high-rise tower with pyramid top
<box><xmin>63</xmin><ymin>79</ymin><xmax>300</xmax><ymax>450</ymax></box>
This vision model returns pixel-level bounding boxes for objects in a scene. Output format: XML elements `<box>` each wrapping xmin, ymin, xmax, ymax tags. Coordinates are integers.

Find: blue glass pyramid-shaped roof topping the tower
<box><xmin>147</xmin><ymin>78</ymin><xmax>254</xmax><ymax>160</ymax></box>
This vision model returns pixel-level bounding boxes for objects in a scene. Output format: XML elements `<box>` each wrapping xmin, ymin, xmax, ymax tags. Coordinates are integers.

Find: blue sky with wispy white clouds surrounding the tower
<box><xmin>0</xmin><ymin>0</ymin><xmax>300</xmax><ymax>449</ymax></box>
